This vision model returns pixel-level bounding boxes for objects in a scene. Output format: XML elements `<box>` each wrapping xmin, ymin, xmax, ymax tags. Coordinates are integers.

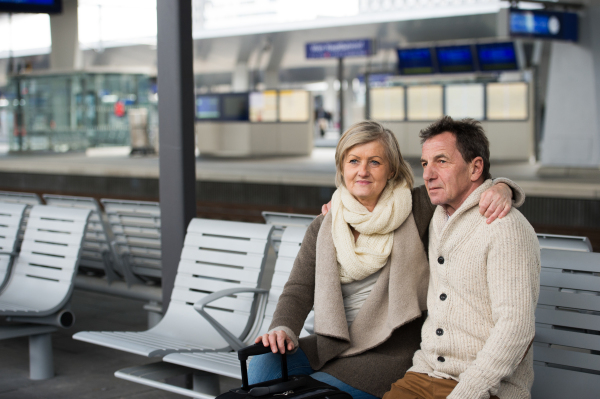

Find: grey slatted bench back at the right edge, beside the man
<box><xmin>532</xmin><ymin>249</ymin><xmax>600</xmax><ymax>399</ymax></box>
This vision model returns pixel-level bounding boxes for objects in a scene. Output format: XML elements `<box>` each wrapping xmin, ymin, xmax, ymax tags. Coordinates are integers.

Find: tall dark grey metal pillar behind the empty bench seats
<box><xmin>157</xmin><ymin>0</ymin><xmax>196</xmax><ymax>311</ymax></box>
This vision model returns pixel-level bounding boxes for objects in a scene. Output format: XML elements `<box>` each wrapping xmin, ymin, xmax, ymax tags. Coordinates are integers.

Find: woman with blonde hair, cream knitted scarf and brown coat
<box><xmin>248</xmin><ymin>121</ymin><xmax>511</xmax><ymax>399</ymax></box>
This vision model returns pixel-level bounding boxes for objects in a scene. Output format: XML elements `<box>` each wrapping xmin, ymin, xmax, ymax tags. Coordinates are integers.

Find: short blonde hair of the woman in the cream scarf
<box><xmin>335</xmin><ymin>121</ymin><xmax>414</xmax><ymax>189</ymax></box>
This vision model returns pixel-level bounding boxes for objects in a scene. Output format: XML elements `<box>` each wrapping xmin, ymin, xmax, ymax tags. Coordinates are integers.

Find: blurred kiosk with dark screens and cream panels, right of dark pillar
<box><xmin>195</xmin><ymin>90</ymin><xmax>314</xmax><ymax>157</ymax></box>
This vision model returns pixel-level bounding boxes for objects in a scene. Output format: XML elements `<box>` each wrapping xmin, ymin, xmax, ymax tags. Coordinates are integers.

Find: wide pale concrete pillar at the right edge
<box><xmin>541</xmin><ymin>5</ymin><xmax>600</xmax><ymax>168</ymax></box>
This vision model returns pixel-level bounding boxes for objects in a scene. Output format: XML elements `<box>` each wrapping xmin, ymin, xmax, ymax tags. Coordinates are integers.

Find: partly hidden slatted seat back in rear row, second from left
<box><xmin>42</xmin><ymin>194</ymin><xmax>118</xmax><ymax>282</ymax></box>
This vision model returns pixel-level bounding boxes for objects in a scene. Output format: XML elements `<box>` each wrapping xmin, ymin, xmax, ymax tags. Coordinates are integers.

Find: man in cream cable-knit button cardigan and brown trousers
<box><xmin>384</xmin><ymin>117</ymin><xmax>540</xmax><ymax>399</ymax></box>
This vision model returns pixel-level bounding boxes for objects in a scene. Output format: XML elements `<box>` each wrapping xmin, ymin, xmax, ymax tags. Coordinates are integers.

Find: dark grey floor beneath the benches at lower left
<box><xmin>0</xmin><ymin>290</ymin><xmax>183</xmax><ymax>399</ymax></box>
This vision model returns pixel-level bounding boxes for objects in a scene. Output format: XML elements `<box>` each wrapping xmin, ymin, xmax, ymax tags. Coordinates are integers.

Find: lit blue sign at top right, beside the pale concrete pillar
<box><xmin>509</xmin><ymin>8</ymin><xmax>579</xmax><ymax>42</ymax></box>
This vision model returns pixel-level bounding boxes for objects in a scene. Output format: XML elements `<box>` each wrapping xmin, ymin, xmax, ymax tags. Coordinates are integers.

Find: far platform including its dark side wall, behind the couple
<box><xmin>0</xmin><ymin>147</ymin><xmax>600</xmax><ymax>250</ymax></box>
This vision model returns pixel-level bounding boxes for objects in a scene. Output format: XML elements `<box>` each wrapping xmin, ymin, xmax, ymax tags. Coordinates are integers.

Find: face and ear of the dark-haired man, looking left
<box><xmin>421</xmin><ymin>132</ymin><xmax>483</xmax><ymax>215</ymax></box>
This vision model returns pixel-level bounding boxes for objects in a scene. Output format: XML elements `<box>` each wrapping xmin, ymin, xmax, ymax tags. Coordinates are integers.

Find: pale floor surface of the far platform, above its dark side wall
<box><xmin>0</xmin><ymin>148</ymin><xmax>600</xmax><ymax>199</ymax></box>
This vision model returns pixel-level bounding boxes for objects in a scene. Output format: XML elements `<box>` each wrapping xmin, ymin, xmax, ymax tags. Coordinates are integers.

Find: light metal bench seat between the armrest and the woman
<box><xmin>115</xmin><ymin>227</ymin><xmax>306</xmax><ymax>399</ymax></box>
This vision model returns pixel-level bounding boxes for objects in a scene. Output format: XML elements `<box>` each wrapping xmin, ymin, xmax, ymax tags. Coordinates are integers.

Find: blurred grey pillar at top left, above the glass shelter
<box><xmin>50</xmin><ymin>0</ymin><xmax>81</xmax><ymax>70</ymax></box>
